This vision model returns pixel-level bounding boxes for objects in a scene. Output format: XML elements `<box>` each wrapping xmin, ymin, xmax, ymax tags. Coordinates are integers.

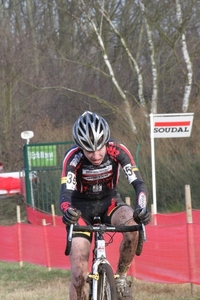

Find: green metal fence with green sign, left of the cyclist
<box><xmin>24</xmin><ymin>141</ymin><xmax>73</xmax><ymax>214</ymax></box>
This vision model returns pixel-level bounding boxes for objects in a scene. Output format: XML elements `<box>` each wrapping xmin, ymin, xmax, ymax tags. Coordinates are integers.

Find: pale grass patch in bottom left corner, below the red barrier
<box><xmin>0</xmin><ymin>262</ymin><xmax>69</xmax><ymax>300</ymax></box>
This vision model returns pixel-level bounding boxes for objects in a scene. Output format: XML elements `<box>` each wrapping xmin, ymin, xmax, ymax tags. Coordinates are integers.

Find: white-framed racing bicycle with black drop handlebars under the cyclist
<box><xmin>65</xmin><ymin>217</ymin><xmax>146</xmax><ymax>300</ymax></box>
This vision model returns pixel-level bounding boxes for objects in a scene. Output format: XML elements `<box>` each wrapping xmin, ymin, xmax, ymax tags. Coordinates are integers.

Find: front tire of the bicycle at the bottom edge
<box><xmin>97</xmin><ymin>263</ymin><xmax>118</xmax><ymax>300</ymax></box>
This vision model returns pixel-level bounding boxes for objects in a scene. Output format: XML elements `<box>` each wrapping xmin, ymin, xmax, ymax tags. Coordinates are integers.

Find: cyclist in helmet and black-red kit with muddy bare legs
<box><xmin>60</xmin><ymin>111</ymin><xmax>150</xmax><ymax>300</ymax></box>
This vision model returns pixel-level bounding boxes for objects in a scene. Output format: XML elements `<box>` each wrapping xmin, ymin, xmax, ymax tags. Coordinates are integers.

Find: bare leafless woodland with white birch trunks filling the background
<box><xmin>0</xmin><ymin>0</ymin><xmax>200</xmax><ymax>171</ymax></box>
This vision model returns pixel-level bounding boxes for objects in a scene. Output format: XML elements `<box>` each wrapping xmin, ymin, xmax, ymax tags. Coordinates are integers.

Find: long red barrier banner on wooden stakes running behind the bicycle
<box><xmin>0</xmin><ymin>207</ymin><xmax>200</xmax><ymax>284</ymax></box>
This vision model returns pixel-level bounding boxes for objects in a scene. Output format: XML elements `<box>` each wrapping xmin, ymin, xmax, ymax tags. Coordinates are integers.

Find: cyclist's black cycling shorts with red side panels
<box><xmin>69</xmin><ymin>191</ymin><xmax>127</xmax><ymax>242</ymax></box>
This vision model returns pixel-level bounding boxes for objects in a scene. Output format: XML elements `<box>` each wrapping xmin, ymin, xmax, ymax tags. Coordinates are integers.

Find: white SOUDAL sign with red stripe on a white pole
<box><xmin>153</xmin><ymin>114</ymin><xmax>193</xmax><ymax>138</ymax></box>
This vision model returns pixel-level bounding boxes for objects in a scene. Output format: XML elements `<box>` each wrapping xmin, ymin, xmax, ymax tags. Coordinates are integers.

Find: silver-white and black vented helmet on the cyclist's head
<box><xmin>72</xmin><ymin>111</ymin><xmax>110</xmax><ymax>151</ymax></box>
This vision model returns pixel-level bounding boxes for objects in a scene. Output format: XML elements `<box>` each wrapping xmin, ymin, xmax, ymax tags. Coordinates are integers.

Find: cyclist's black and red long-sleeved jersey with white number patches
<box><xmin>60</xmin><ymin>141</ymin><xmax>147</xmax><ymax>211</ymax></box>
